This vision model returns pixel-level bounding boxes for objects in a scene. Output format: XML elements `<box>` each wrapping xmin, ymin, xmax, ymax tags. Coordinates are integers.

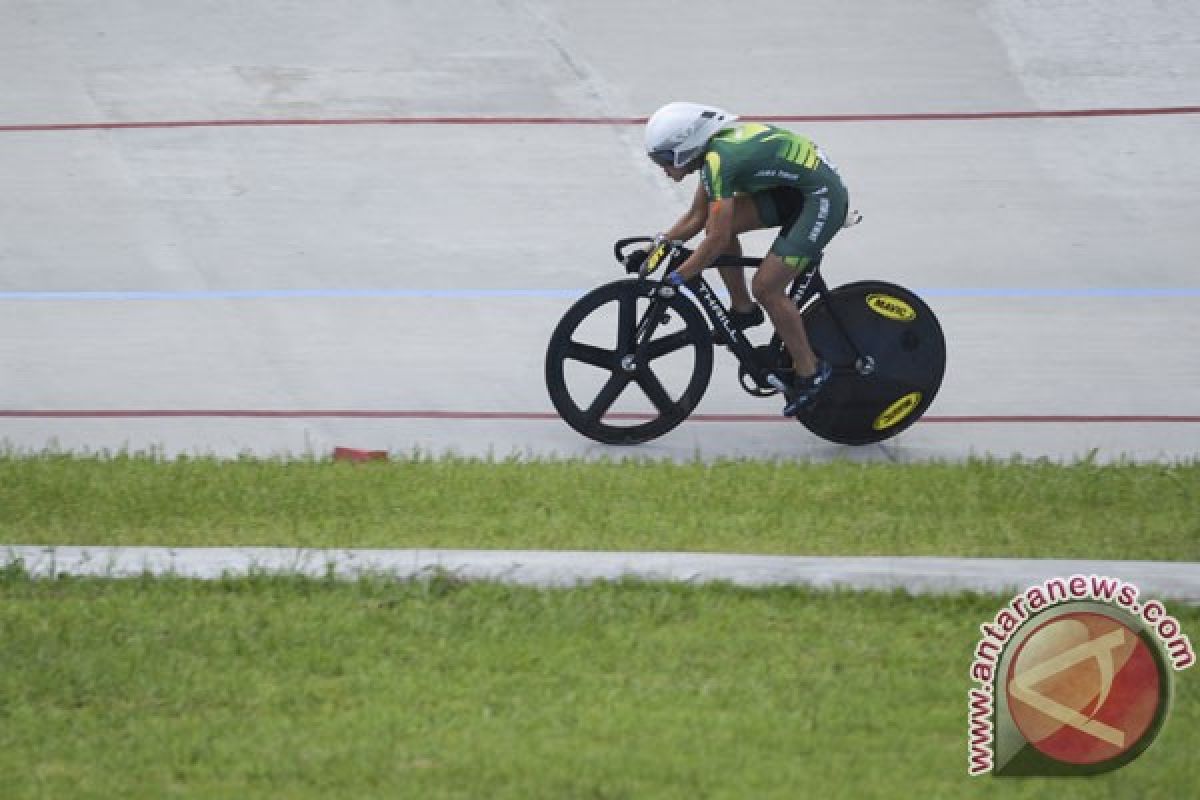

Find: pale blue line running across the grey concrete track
<box><xmin>0</xmin><ymin>287</ymin><xmax>1200</xmax><ymax>302</ymax></box>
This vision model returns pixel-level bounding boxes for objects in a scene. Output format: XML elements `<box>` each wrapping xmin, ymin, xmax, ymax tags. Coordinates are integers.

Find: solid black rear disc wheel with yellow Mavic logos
<box><xmin>800</xmin><ymin>281</ymin><xmax>946</xmax><ymax>445</ymax></box>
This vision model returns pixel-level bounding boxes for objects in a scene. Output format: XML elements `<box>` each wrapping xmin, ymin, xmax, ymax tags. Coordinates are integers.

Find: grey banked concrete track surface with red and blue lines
<box><xmin>0</xmin><ymin>0</ymin><xmax>1200</xmax><ymax>462</ymax></box>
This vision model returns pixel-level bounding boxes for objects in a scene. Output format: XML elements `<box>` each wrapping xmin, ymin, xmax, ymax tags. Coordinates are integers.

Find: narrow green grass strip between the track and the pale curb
<box><xmin>0</xmin><ymin>456</ymin><xmax>1200</xmax><ymax>561</ymax></box>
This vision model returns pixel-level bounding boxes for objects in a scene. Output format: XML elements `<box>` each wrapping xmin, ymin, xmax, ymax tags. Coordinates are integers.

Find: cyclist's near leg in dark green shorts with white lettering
<box><xmin>754</xmin><ymin>181</ymin><xmax>847</xmax><ymax>375</ymax></box>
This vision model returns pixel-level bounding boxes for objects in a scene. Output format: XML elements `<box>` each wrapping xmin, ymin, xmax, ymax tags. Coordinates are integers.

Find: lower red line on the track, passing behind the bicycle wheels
<box><xmin>0</xmin><ymin>409</ymin><xmax>1200</xmax><ymax>425</ymax></box>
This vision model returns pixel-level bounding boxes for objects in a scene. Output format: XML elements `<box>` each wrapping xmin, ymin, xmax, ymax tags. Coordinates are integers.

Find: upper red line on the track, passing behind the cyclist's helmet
<box><xmin>0</xmin><ymin>106</ymin><xmax>1200</xmax><ymax>133</ymax></box>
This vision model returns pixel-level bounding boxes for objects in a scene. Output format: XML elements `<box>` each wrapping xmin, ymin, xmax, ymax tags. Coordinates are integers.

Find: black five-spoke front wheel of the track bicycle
<box><xmin>546</xmin><ymin>278</ymin><xmax>713</xmax><ymax>445</ymax></box>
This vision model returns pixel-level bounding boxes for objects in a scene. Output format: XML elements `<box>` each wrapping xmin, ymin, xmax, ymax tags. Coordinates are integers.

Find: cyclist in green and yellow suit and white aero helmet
<box><xmin>646</xmin><ymin>103</ymin><xmax>848</xmax><ymax>416</ymax></box>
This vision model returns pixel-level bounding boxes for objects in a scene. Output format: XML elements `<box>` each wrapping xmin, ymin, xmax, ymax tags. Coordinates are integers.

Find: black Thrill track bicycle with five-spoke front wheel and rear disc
<box><xmin>546</xmin><ymin>236</ymin><xmax>946</xmax><ymax>445</ymax></box>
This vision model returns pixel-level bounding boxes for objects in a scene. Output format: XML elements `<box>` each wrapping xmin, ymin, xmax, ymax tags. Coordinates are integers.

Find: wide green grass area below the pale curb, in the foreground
<box><xmin>0</xmin><ymin>570</ymin><xmax>1200</xmax><ymax>800</ymax></box>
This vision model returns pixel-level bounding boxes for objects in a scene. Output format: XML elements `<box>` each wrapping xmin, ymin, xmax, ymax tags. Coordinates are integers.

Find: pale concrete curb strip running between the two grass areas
<box><xmin>0</xmin><ymin>545</ymin><xmax>1200</xmax><ymax>604</ymax></box>
